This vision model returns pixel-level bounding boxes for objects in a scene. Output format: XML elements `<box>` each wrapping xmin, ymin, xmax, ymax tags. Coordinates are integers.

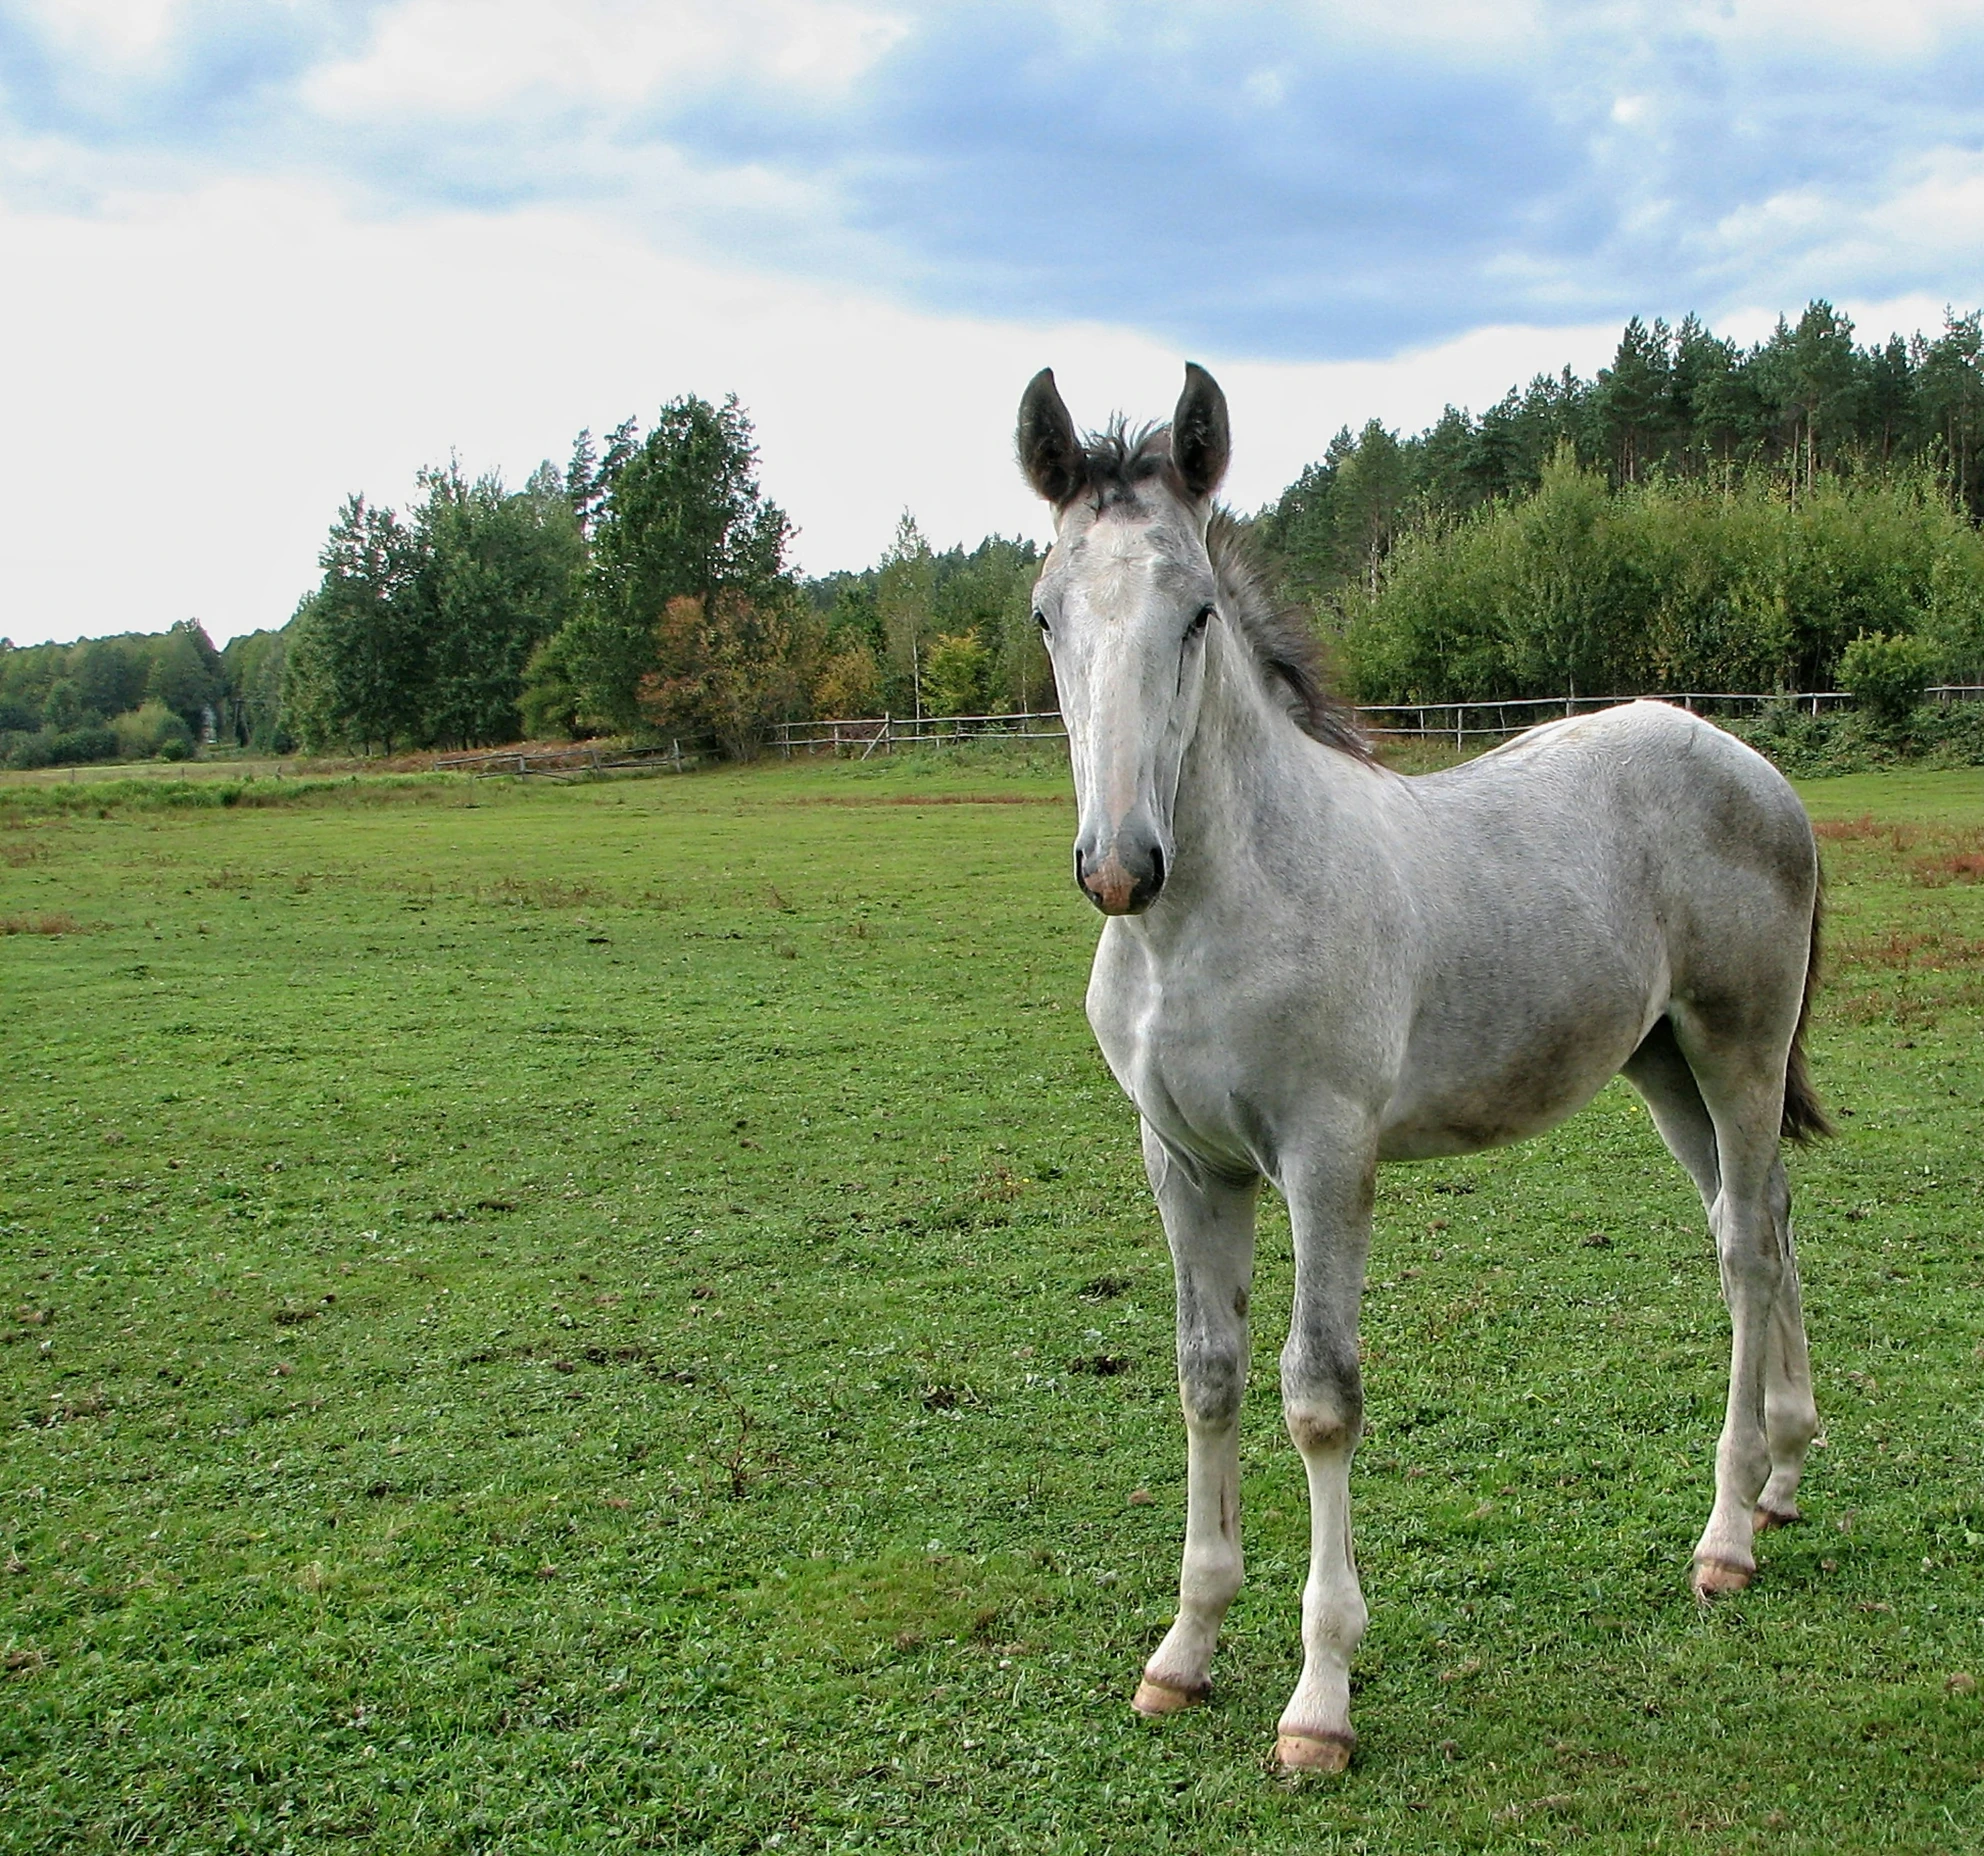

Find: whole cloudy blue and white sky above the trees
<box><xmin>0</xmin><ymin>0</ymin><xmax>1984</xmax><ymax>643</ymax></box>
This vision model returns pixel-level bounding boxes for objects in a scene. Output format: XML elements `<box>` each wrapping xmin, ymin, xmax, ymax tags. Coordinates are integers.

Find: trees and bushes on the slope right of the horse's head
<box><xmin>1254</xmin><ymin>302</ymin><xmax>1984</xmax><ymax>703</ymax></box>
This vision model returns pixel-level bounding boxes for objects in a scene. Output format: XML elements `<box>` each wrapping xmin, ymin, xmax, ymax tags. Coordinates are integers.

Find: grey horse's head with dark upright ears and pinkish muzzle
<box><xmin>1018</xmin><ymin>363</ymin><xmax>1232</xmax><ymax>915</ymax></box>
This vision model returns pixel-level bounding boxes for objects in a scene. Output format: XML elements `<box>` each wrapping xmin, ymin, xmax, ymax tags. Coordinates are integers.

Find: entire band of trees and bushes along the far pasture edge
<box><xmin>0</xmin><ymin>302</ymin><xmax>1984</xmax><ymax>766</ymax></box>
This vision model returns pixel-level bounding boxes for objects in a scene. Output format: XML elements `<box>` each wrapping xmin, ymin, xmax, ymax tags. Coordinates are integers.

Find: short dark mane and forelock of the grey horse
<box><xmin>1081</xmin><ymin>417</ymin><xmax>1373</xmax><ymax>760</ymax></box>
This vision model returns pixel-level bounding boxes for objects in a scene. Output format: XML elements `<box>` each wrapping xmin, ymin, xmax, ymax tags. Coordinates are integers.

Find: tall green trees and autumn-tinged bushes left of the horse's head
<box><xmin>280</xmin><ymin>397</ymin><xmax>1050</xmax><ymax>756</ymax></box>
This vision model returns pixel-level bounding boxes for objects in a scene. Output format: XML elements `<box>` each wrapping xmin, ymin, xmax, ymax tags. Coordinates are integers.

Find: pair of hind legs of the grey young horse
<box><xmin>1666</xmin><ymin>1000</ymin><xmax>1817</xmax><ymax>1598</ymax></box>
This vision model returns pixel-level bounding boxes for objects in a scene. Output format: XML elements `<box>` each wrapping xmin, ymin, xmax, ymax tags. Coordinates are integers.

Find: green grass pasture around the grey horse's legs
<box><xmin>0</xmin><ymin>760</ymin><xmax>1984</xmax><ymax>1856</ymax></box>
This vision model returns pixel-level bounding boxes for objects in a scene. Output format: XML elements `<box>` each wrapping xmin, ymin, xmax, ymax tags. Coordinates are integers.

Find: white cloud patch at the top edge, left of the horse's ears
<box><xmin>306</xmin><ymin>0</ymin><xmax>907</xmax><ymax>115</ymax></box>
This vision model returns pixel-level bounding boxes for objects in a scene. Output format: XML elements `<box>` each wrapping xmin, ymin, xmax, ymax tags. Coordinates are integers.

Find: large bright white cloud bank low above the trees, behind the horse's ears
<box><xmin>0</xmin><ymin>183</ymin><xmax>1615</xmax><ymax>643</ymax></box>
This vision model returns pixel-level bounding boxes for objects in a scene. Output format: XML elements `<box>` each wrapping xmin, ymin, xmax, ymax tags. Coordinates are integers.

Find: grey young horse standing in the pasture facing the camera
<box><xmin>1018</xmin><ymin>367</ymin><xmax>1827</xmax><ymax>1771</ymax></box>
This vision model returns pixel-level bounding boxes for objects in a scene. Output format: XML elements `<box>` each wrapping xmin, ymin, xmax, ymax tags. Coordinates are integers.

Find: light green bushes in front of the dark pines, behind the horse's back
<box><xmin>1335</xmin><ymin>455</ymin><xmax>1984</xmax><ymax>713</ymax></box>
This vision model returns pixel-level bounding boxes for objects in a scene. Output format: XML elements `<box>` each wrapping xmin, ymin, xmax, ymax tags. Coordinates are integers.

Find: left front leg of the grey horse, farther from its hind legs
<box><xmin>1133</xmin><ymin>1124</ymin><xmax>1260</xmax><ymax>1717</ymax></box>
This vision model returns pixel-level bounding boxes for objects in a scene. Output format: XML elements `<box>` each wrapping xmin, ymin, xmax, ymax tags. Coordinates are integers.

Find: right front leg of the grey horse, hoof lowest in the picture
<box><xmin>1276</xmin><ymin>1157</ymin><xmax>1377</xmax><ymax>1773</ymax></box>
